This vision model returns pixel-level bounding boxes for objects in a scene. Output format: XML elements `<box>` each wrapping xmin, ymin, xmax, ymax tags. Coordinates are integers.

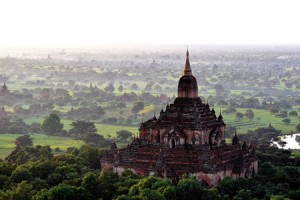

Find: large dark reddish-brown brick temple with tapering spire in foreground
<box><xmin>101</xmin><ymin>51</ymin><xmax>257</xmax><ymax>186</ymax></box>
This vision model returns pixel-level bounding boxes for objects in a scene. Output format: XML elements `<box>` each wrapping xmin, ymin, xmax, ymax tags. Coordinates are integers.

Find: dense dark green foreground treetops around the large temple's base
<box><xmin>0</xmin><ymin>145</ymin><xmax>300</xmax><ymax>200</ymax></box>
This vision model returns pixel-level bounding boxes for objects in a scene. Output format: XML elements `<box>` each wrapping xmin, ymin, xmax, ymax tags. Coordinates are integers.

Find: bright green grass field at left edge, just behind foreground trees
<box><xmin>0</xmin><ymin>134</ymin><xmax>84</xmax><ymax>159</ymax></box>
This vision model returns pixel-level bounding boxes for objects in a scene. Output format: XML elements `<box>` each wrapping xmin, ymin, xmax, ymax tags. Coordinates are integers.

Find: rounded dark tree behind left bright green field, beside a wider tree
<box><xmin>41</xmin><ymin>114</ymin><xmax>64</xmax><ymax>135</ymax></box>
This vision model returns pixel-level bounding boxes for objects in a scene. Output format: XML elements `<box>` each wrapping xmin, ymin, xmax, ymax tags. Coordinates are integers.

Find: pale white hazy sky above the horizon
<box><xmin>0</xmin><ymin>0</ymin><xmax>300</xmax><ymax>47</ymax></box>
